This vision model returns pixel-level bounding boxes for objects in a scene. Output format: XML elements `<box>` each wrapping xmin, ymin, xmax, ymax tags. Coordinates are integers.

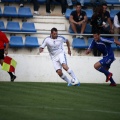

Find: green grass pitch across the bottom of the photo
<box><xmin>0</xmin><ymin>82</ymin><xmax>120</xmax><ymax>120</ymax></box>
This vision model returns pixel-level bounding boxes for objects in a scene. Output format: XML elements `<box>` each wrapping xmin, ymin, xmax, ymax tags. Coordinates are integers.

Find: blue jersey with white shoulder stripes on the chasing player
<box><xmin>88</xmin><ymin>37</ymin><xmax>114</xmax><ymax>57</ymax></box>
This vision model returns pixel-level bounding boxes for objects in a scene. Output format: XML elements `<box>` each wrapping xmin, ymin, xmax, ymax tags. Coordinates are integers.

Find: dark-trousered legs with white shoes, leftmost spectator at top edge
<box><xmin>20</xmin><ymin>0</ymin><xmax>39</xmax><ymax>15</ymax></box>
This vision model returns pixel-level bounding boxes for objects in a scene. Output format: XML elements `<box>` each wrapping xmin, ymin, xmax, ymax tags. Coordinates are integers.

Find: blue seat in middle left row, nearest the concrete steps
<box><xmin>21</xmin><ymin>22</ymin><xmax>36</xmax><ymax>32</ymax></box>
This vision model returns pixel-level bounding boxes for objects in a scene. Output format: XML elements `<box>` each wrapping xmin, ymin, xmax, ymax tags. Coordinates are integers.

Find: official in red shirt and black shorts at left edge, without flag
<box><xmin>0</xmin><ymin>31</ymin><xmax>16</xmax><ymax>82</ymax></box>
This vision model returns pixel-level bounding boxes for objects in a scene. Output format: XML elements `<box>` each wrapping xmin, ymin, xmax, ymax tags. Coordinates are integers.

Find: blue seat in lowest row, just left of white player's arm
<box><xmin>25</xmin><ymin>36</ymin><xmax>40</xmax><ymax>48</ymax></box>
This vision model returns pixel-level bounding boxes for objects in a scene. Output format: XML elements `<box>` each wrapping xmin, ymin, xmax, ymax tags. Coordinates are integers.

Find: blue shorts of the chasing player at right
<box><xmin>99</xmin><ymin>57</ymin><xmax>115</xmax><ymax>69</ymax></box>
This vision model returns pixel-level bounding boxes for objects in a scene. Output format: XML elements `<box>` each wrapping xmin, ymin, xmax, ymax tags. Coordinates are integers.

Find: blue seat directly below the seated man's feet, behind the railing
<box><xmin>72</xmin><ymin>38</ymin><xmax>88</xmax><ymax>49</ymax></box>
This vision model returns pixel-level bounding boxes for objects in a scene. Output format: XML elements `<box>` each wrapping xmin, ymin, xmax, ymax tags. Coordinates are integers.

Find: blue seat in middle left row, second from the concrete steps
<box><xmin>6</xmin><ymin>21</ymin><xmax>21</xmax><ymax>32</ymax></box>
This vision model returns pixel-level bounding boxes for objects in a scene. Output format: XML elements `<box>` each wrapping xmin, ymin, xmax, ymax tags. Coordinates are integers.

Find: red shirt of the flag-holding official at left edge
<box><xmin>0</xmin><ymin>31</ymin><xmax>9</xmax><ymax>49</ymax></box>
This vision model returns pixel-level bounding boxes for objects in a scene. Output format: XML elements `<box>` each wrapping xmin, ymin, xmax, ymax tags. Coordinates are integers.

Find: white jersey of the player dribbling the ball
<box><xmin>40</xmin><ymin>36</ymin><xmax>67</xmax><ymax>58</ymax></box>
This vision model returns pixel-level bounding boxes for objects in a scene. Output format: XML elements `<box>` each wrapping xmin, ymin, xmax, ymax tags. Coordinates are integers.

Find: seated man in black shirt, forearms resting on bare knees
<box><xmin>69</xmin><ymin>2</ymin><xmax>87</xmax><ymax>38</ymax></box>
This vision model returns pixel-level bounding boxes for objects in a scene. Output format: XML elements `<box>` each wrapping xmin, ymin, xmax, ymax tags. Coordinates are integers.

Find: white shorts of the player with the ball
<box><xmin>52</xmin><ymin>53</ymin><xmax>67</xmax><ymax>71</ymax></box>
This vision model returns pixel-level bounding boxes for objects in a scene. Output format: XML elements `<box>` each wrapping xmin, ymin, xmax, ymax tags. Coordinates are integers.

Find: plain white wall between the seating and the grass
<box><xmin>0</xmin><ymin>54</ymin><xmax>120</xmax><ymax>84</ymax></box>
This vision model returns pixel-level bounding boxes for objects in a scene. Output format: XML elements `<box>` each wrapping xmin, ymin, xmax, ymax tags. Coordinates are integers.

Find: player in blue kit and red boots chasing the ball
<box><xmin>86</xmin><ymin>32</ymin><xmax>120</xmax><ymax>86</ymax></box>
